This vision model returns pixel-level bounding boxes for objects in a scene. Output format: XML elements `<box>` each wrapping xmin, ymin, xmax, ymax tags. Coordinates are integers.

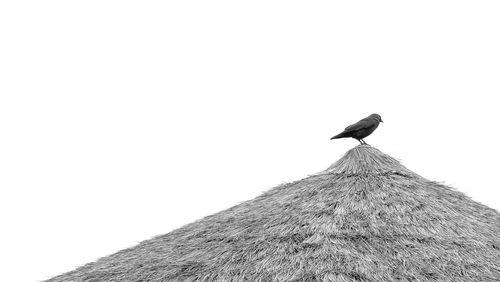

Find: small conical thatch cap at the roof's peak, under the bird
<box><xmin>321</xmin><ymin>145</ymin><xmax>416</xmax><ymax>175</ymax></box>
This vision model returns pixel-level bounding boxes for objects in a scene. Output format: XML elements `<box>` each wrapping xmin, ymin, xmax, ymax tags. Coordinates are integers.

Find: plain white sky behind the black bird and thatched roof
<box><xmin>0</xmin><ymin>0</ymin><xmax>500</xmax><ymax>282</ymax></box>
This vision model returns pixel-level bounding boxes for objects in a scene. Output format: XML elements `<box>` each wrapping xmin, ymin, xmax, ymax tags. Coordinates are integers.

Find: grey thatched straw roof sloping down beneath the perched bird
<box><xmin>49</xmin><ymin>146</ymin><xmax>500</xmax><ymax>282</ymax></box>
